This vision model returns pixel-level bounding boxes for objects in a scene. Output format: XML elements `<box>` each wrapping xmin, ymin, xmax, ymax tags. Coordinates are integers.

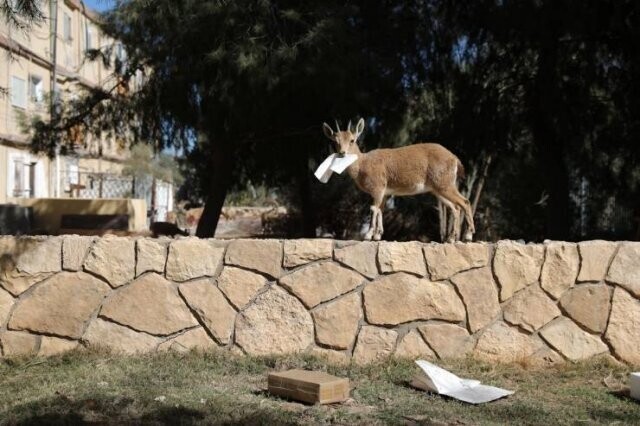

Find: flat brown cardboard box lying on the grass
<box><xmin>267</xmin><ymin>370</ymin><xmax>349</xmax><ymax>404</ymax></box>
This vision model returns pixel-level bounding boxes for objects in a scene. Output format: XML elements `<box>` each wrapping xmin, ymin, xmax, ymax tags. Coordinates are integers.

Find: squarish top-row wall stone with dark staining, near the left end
<box><xmin>14</xmin><ymin>237</ymin><xmax>62</xmax><ymax>275</ymax></box>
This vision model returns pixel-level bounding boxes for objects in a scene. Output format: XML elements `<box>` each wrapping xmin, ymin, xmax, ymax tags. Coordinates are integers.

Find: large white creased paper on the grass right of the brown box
<box><xmin>414</xmin><ymin>360</ymin><xmax>513</xmax><ymax>404</ymax></box>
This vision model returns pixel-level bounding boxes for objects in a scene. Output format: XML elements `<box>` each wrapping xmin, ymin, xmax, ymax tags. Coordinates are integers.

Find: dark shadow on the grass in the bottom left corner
<box><xmin>0</xmin><ymin>395</ymin><xmax>297</xmax><ymax>426</ymax></box>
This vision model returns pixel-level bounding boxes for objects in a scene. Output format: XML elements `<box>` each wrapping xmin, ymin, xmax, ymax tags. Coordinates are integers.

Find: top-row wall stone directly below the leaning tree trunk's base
<box><xmin>166</xmin><ymin>238</ymin><xmax>224</xmax><ymax>281</ymax></box>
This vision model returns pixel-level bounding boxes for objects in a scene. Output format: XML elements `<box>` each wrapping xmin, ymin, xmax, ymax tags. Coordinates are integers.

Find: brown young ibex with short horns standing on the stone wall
<box><xmin>322</xmin><ymin>118</ymin><xmax>475</xmax><ymax>242</ymax></box>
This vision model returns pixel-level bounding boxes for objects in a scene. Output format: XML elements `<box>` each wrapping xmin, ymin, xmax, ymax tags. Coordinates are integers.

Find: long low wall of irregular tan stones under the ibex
<box><xmin>0</xmin><ymin>236</ymin><xmax>640</xmax><ymax>364</ymax></box>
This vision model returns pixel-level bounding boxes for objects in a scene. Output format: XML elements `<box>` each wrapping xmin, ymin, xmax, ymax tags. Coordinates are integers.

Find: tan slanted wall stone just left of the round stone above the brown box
<box><xmin>180</xmin><ymin>278</ymin><xmax>236</xmax><ymax>344</ymax></box>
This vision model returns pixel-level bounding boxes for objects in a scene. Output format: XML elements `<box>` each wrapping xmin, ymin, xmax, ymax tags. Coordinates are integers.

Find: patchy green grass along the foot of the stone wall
<box><xmin>0</xmin><ymin>351</ymin><xmax>640</xmax><ymax>425</ymax></box>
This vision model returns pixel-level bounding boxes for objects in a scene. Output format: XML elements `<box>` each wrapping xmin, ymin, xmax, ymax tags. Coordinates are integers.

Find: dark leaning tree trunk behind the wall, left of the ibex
<box><xmin>196</xmin><ymin>141</ymin><xmax>233</xmax><ymax>238</ymax></box>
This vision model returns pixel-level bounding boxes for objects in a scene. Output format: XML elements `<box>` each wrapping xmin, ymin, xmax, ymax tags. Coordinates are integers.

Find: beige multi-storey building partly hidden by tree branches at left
<box><xmin>0</xmin><ymin>0</ymin><xmax>173</xmax><ymax>225</ymax></box>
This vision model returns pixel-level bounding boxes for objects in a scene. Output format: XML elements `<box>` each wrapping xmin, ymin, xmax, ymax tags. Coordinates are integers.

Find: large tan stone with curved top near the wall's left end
<box><xmin>9</xmin><ymin>272</ymin><xmax>110</xmax><ymax>339</ymax></box>
